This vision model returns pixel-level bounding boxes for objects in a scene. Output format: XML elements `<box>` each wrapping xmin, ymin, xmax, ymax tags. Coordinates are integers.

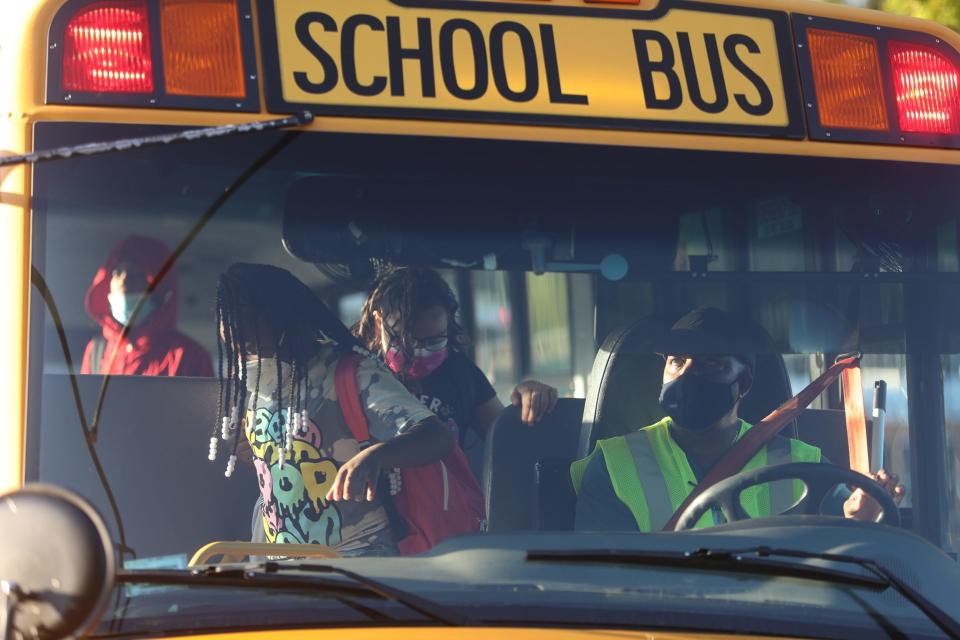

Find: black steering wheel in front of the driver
<box><xmin>674</xmin><ymin>462</ymin><xmax>900</xmax><ymax>531</ymax></box>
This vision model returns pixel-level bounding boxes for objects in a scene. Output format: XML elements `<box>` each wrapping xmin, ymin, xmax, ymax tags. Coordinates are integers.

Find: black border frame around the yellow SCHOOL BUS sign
<box><xmin>257</xmin><ymin>0</ymin><xmax>805</xmax><ymax>139</ymax></box>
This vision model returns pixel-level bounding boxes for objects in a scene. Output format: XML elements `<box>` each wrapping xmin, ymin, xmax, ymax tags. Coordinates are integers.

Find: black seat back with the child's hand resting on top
<box><xmin>483</xmin><ymin>398</ymin><xmax>583</xmax><ymax>532</ymax></box>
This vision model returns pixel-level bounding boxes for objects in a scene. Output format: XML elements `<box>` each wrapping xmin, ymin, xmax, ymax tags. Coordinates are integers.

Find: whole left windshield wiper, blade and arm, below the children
<box><xmin>118</xmin><ymin>561</ymin><xmax>474</xmax><ymax>627</ymax></box>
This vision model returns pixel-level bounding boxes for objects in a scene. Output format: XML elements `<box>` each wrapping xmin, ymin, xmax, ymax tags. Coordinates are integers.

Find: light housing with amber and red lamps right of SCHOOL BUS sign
<box><xmin>793</xmin><ymin>14</ymin><xmax>960</xmax><ymax>149</ymax></box>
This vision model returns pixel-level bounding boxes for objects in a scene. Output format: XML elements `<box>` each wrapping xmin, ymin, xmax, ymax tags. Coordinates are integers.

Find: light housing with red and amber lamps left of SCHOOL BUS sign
<box><xmin>48</xmin><ymin>0</ymin><xmax>260</xmax><ymax>113</ymax></box>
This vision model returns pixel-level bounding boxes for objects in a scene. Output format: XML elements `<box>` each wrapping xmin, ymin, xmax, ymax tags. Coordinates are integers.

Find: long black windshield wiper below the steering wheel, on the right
<box><xmin>527</xmin><ymin>546</ymin><xmax>960</xmax><ymax>640</ymax></box>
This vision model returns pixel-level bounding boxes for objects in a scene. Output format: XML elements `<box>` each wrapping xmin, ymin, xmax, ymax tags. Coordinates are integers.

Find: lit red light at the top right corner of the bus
<box><xmin>887</xmin><ymin>41</ymin><xmax>960</xmax><ymax>135</ymax></box>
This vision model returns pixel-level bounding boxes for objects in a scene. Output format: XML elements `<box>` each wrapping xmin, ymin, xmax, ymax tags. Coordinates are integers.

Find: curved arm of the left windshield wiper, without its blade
<box><xmin>193</xmin><ymin>561</ymin><xmax>475</xmax><ymax>627</ymax></box>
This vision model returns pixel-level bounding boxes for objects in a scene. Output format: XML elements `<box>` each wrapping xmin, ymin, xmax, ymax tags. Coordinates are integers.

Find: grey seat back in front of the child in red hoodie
<box><xmin>30</xmin><ymin>374</ymin><xmax>253</xmax><ymax>558</ymax></box>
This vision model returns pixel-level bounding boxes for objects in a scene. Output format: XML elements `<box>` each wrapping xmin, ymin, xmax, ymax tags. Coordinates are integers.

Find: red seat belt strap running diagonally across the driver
<box><xmin>663</xmin><ymin>355</ymin><xmax>863</xmax><ymax>531</ymax></box>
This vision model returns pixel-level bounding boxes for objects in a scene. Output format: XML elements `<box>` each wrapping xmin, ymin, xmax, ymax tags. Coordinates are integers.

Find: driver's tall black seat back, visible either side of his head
<box><xmin>577</xmin><ymin>318</ymin><xmax>796</xmax><ymax>458</ymax></box>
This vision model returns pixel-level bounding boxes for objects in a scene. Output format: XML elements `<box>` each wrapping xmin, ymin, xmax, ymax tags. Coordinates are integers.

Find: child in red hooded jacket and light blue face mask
<box><xmin>80</xmin><ymin>236</ymin><xmax>213</xmax><ymax>376</ymax></box>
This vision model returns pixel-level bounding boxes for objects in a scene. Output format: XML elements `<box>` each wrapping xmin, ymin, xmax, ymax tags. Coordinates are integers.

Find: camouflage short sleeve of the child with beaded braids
<box><xmin>357</xmin><ymin>359</ymin><xmax>433</xmax><ymax>441</ymax></box>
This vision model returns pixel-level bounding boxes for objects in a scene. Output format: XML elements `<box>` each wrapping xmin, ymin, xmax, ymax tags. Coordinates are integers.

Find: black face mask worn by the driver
<box><xmin>660</xmin><ymin>373</ymin><xmax>740</xmax><ymax>431</ymax></box>
